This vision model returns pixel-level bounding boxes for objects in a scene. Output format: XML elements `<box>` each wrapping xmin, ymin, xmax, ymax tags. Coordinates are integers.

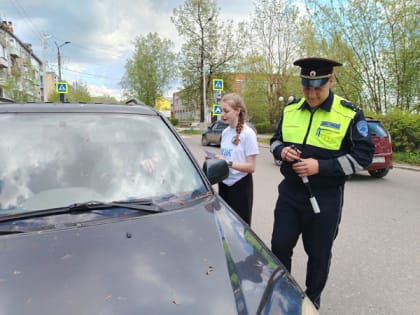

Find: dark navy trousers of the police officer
<box><xmin>271</xmin><ymin>181</ymin><xmax>344</xmax><ymax>308</ymax></box>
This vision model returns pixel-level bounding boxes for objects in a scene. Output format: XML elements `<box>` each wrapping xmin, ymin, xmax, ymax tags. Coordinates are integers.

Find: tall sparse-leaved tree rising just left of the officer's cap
<box><xmin>248</xmin><ymin>0</ymin><xmax>299</xmax><ymax>125</ymax></box>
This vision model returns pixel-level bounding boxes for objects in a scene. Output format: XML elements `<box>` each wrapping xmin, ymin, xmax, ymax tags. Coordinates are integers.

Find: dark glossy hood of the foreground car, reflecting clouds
<box><xmin>0</xmin><ymin>199</ymin><xmax>300</xmax><ymax>315</ymax></box>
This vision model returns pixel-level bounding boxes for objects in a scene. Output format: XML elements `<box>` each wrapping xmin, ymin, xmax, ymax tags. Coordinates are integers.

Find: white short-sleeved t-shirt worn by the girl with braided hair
<box><xmin>220</xmin><ymin>124</ymin><xmax>260</xmax><ymax>186</ymax></box>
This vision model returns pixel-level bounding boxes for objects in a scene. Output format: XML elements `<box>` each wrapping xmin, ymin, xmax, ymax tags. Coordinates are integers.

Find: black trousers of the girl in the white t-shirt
<box><xmin>219</xmin><ymin>173</ymin><xmax>254</xmax><ymax>226</ymax></box>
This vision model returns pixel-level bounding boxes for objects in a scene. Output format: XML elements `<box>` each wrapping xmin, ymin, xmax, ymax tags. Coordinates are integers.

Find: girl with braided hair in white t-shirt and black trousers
<box><xmin>216</xmin><ymin>93</ymin><xmax>260</xmax><ymax>225</ymax></box>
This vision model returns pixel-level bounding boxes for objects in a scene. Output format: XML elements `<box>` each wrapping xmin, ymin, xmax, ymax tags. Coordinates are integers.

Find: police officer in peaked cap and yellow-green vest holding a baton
<box><xmin>270</xmin><ymin>58</ymin><xmax>374</xmax><ymax>308</ymax></box>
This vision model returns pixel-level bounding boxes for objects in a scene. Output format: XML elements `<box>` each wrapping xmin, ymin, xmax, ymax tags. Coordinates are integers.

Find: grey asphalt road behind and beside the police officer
<box><xmin>183</xmin><ymin>136</ymin><xmax>420</xmax><ymax>315</ymax></box>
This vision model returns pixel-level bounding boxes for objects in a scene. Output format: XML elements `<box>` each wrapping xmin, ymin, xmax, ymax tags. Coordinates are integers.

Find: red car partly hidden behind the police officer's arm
<box><xmin>366</xmin><ymin>118</ymin><xmax>392</xmax><ymax>178</ymax></box>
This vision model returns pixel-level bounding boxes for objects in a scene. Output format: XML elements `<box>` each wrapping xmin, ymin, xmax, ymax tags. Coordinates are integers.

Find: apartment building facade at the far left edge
<box><xmin>0</xmin><ymin>21</ymin><xmax>44</xmax><ymax>102</ymax></box>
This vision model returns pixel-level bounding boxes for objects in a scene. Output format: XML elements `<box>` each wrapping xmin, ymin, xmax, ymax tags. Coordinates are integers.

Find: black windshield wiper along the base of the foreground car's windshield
<box><xmin>0</xmin><ymin>199</ymin><xmax>163</xmax><ymax>222</ymax></box>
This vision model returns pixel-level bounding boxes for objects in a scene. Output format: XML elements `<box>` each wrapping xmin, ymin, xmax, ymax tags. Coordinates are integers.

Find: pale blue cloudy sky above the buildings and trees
<box><xmin>0</xmin><ymin>0</ymin><xmax>254</xmax><ymax>100</ymax></box>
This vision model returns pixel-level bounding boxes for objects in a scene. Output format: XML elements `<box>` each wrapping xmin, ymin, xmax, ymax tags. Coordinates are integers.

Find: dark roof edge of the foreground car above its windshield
<box><xmin>0</xmin><ymin>103</ymin><xmax>159</xmax><ymax>116</ymax></box>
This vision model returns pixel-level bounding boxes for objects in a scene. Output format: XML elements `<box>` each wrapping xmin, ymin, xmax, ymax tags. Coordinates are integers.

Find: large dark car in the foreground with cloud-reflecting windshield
<box><xmin>0</xmin><ymin>103</ymin><xmax>318</xmax><ymax>315</ymax></box>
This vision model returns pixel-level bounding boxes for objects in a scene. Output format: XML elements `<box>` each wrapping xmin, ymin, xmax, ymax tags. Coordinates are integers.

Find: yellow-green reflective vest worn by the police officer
<box><xmin>282</xmin><ymin>95</ymin><xmax>356</xmax><ymax>150</ymax></box>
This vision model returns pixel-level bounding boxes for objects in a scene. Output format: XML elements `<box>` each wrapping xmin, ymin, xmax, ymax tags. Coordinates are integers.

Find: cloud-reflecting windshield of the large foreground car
<box><xmin>0</xmin><ymin>113</ymin><xmax>208</xmax><ymax>215</ymax></box>
